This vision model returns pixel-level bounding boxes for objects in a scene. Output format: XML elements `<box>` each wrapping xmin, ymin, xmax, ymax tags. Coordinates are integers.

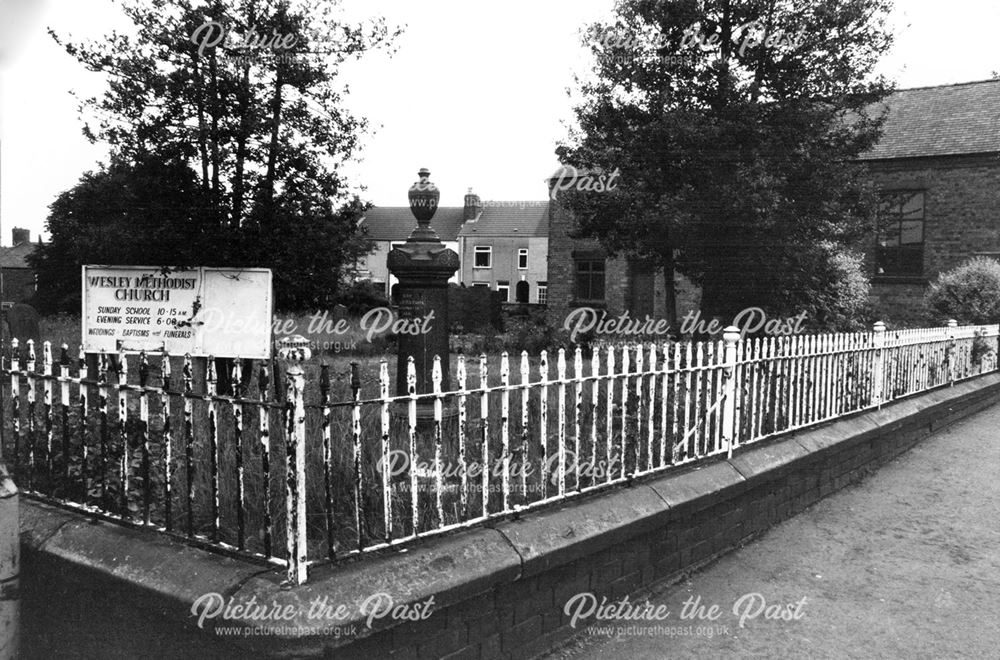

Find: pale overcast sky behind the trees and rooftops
<box><xmin>0</xmin><ymin>0</ymin><xmax>1000</xmax><ymax>245</ymax></box>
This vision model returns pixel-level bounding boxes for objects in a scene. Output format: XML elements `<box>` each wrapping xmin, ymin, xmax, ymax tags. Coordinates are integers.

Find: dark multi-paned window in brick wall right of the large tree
<box><xmin>876</xmin><ymin>190</ymin><xmax>924</xmax><ymax>275</ymax></box>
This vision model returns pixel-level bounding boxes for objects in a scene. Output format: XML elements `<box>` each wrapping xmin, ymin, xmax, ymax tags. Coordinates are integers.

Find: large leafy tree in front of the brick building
<box><xmin>557</xmin><ymin>0</ymin><xmax>891</xmax><ymax>328</ymax></box>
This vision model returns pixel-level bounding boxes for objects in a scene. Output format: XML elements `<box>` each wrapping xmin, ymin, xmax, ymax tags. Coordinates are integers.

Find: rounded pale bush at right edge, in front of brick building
<box><xmin>924</xmin><ymin>257</ymin><xmax>1000</xmax><ymax>325</ymax></box>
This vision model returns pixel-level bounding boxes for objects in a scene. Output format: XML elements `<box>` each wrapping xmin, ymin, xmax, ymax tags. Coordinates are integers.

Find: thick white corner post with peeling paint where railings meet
<box><xmin>285</xmin><ymin>364</ymin><xmax>308</xmax><ymax>584</ymax></box>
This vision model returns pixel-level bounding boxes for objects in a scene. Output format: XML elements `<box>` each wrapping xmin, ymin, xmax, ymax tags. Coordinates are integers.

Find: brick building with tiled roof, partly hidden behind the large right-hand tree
<box><xmin>548</xmin><ymin>80</ymin><xmax>1000</xmax><ymax>323</ymax></box>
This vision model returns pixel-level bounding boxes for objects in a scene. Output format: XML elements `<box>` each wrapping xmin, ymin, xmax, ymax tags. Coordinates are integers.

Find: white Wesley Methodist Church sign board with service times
<box><xmin>83</xmin><ymin>266</ymin><xmax>274</xmax><ymax>359</ymax></box>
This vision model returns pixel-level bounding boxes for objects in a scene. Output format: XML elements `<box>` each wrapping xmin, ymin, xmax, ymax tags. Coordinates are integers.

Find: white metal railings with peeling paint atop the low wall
<box><xmin>3</xmin><ymin>324</ymin><xmax>1000</xmax><ymax>583</ymax></box>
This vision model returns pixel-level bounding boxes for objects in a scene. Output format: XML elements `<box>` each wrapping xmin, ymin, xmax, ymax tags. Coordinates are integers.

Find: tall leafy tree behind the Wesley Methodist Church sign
<box><xmin>38</xmin><ymin>0</ymin><xmax>399</xmax><ymax>306</ymax></box>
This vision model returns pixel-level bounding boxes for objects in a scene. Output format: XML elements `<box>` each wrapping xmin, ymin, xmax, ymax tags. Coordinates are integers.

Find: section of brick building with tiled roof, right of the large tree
<box><xmin>861</xmin><ymin>80</ymin><xmax>1000</xmax><ymax>322</ymax></box>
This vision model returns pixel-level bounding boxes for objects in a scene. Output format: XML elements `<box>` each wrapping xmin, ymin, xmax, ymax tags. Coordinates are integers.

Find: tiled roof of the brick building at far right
<box><xmin>861</xmin><ymin>80</ymin><xmax>1000</xmax><ymax>160</ymax></box>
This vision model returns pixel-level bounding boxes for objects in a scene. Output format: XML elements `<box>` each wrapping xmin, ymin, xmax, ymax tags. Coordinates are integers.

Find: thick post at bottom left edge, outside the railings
<box><xmin>0</xmin><ymin>464</ymin><xmax>20</xmax><ymax>660</ymax></box>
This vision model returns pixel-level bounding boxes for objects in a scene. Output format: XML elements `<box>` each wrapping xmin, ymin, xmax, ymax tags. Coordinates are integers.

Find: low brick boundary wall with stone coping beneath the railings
<box><xmin>21</xmin><ymin>374</ymin><xmax>1000</xmax><ymax>660</ymax></box>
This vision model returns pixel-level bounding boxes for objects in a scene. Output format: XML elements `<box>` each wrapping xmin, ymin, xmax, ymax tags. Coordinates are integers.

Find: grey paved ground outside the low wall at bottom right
<box><xmin>553</xmin><ymin>406</ymin><xmax>1000</xmax><ymax>660</ymax></box>
